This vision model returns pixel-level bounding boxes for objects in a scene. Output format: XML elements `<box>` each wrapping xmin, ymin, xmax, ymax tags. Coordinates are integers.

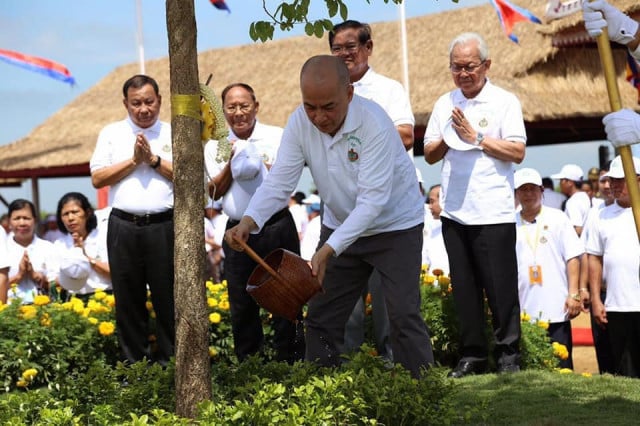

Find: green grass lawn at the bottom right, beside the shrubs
<box><xmin>456</xmin><ymin>371</ymin><xmax>640</xmax><ymax>426</ymax></box>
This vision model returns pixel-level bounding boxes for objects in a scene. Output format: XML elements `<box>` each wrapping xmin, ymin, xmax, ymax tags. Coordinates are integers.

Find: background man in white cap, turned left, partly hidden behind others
<box><xmin>551</xmin><ymin>164</ymin><xmax>591</xmax><ymax>235</ymax></box>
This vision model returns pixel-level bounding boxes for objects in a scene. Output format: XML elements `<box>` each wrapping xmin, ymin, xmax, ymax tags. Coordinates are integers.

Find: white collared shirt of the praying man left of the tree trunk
<box><xmin>90</xmin><ymin>117</ymin><xmax>173</xmax><ymax>214</ymax></box>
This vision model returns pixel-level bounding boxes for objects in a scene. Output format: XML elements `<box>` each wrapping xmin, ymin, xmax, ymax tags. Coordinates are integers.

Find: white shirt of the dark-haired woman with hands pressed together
<box><xmin>54</xmin><ymin>227</ymin><xmax>111</xmax><ymax>294</ymax></box>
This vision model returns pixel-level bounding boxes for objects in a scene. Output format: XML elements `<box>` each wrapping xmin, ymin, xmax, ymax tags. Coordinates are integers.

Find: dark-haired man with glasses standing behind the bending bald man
<box><xmin>329</xmin><ymin>20</ymin><xmax>415</xmax><ymax>361</ymax></box>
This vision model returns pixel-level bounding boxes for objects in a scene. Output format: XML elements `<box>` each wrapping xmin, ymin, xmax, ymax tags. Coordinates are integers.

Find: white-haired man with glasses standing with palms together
<box><xmin>424</xmin><ymin>33</ymin><xmax>527</xmax><ymax>378</ymax></box>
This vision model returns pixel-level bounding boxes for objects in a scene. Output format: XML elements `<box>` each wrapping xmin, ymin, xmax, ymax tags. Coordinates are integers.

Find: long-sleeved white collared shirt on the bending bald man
<box><xmin>245</xmin><ymin>95</ymin><xmax>423</xmax><ymax>255</ymax></box>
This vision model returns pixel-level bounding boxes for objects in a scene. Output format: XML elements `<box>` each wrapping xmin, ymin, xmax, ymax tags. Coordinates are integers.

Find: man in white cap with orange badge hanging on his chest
<box><xmin>514</xmin><ymin>168</ymin><xmax>584</xmax><ymax>368</ymax></box>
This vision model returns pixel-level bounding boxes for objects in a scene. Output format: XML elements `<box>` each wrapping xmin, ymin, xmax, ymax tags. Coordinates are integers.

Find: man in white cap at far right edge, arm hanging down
<box><xmin>587</xmin><ymin>156</ymin><xmax>640</xmax><ymax>377</ymax></box>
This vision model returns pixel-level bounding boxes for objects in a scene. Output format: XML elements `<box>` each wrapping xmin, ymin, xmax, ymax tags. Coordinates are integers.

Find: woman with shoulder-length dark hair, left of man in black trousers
<box><xmin>55</xmin><ymin>192</ymin><xmax>111</xmax><ymax>298</ymax></box>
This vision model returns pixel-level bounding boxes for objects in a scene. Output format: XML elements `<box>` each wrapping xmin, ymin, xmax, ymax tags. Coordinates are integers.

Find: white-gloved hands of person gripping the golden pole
<box><xmin>582</xmin><ymin>0</ymin><xmax>640</xmax><ymax>147</ymax></box>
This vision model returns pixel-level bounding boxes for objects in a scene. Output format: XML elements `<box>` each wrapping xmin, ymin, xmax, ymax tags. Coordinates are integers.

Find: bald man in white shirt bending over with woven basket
<box><xmin>225</xmin><ymin>55</ymin><xmax>433</xmax><ymax>377</ymax></box>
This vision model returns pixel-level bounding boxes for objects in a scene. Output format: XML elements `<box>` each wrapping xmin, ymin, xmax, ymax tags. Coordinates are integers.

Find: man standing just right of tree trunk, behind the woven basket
<box><xmin>204</xmin><ymin>83</ymin><xmax>305</xmax><ymax>363</ymax></box>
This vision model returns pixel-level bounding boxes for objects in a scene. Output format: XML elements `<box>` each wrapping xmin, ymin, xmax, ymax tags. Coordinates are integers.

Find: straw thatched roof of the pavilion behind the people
<box><xmin>0</xmin><ymin>0</ymin><xmax>640</xmax><ymax>177</ymax></box>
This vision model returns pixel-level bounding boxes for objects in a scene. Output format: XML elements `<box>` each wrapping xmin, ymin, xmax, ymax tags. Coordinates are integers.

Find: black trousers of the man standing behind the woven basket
<box><xmin>222</xmin><ymin>209</ymin><xmax>305</xmax><ymax>363</ymax></box>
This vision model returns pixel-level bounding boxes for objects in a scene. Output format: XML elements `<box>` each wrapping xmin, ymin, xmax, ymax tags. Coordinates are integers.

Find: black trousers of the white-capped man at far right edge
<box><xmin>607</xmin><ymin>311</ymin><xmax>640</xmax><ymax>377</ymax></box>
